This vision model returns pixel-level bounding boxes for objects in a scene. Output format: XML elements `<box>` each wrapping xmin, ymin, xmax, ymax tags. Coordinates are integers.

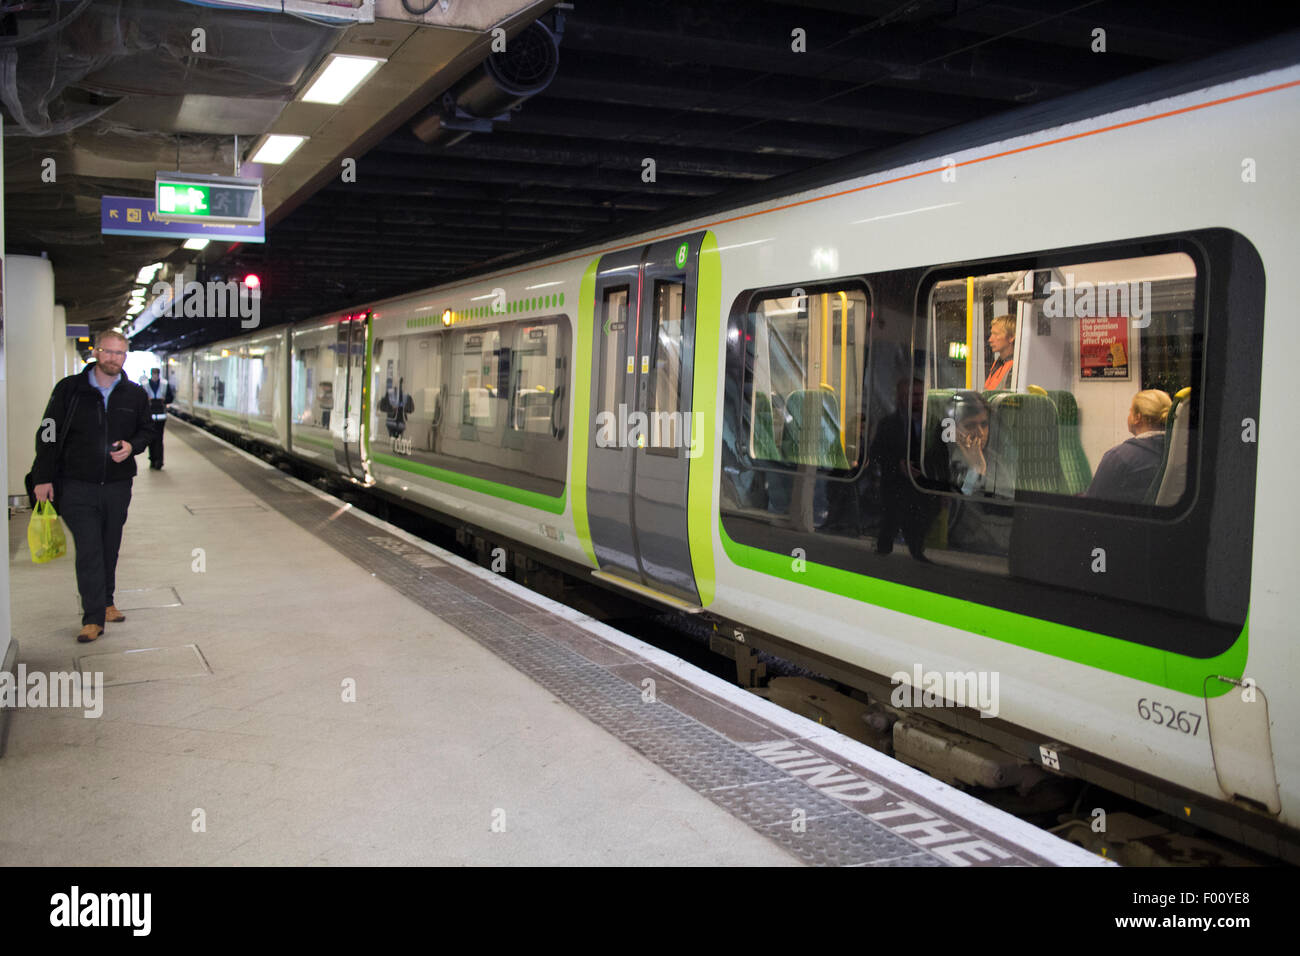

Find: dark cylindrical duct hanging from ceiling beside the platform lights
<box><xmin>411</xmin><ymin>10</ymin><xmax>564</xmax><ymax>147</ymax></box>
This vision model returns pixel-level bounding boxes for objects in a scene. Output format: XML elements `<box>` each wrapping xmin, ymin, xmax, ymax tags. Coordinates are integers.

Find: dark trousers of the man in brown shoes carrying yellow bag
<box><xmin>56</xmin><ymin>479</ymin><xmax>131</xmax><ymax>627</ymax></box>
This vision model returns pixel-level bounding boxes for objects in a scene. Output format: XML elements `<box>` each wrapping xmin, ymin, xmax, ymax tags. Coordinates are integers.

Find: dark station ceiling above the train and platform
<box><xmin>0</xmin><ymin>0</ymin><xmax>1300</xmax><ymax>349</ymax></box>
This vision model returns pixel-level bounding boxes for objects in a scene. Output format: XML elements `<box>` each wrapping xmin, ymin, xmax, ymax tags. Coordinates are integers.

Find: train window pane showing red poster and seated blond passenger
<box><xmin>917</xmin><ymin>252</ymin><xmax>1196</xmax><ymax>528</ymax></box>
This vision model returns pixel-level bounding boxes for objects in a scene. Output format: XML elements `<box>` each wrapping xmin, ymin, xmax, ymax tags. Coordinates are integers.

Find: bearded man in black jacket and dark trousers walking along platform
<box><xmin>31</xmin><ymin>332</ymin><xmax>155</xmax><ymax>644</ymax></box>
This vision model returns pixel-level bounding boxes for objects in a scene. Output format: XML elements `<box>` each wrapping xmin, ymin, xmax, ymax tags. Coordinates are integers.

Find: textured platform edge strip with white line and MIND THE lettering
<box><xmin>177</xmin><ymin>424</ymin><xmax>1114</xmax><ymax>866</ymax></box>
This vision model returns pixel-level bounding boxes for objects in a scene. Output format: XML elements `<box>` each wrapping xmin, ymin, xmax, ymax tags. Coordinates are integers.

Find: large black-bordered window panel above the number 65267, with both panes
<box><xmin>719</xmin><ymin>229</ymin><xmax>1248</xmax><ymax>657</ymax></box>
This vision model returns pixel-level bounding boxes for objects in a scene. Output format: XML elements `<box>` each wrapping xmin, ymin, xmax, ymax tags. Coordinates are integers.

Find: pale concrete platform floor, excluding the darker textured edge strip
<box><xmin>0</xmin><ymin>425</ymin><xmax>798</xmax><ymax>866</ymax></box>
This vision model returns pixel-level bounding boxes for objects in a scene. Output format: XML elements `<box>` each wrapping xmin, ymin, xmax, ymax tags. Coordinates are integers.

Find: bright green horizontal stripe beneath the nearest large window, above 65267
<box><xmin>718</xmin><ymin>522</ymin><xmax>1251</xmax><ymax>697</ymax></box>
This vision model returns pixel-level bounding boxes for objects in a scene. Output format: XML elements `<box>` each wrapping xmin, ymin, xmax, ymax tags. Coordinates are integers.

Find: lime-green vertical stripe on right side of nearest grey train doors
<box><xmin>686</xmin><ymin>232</ymin><xmax>723</xmax><ymax>607</ymax></box>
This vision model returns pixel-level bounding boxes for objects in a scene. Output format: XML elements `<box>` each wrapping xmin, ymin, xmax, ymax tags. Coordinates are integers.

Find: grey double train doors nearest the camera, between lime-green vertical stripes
<box><xmin>586</xmin><ymin>234</ymin><xmax>702</xmax><ymax>605</ymax></box>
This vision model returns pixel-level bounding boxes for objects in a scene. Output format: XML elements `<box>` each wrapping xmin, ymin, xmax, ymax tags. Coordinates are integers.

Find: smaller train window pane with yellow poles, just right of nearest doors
<box><xmin>745</xmin><ymin>286</ymin><xmax>868</xmax><ymax>470</ymax></box>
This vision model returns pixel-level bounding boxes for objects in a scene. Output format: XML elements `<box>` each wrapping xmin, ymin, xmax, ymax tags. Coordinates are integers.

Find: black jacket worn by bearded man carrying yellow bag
<box><xmin>31</xmin><ymin>365</ymin><xmax>155</xmax><ymax>485</ymax></box>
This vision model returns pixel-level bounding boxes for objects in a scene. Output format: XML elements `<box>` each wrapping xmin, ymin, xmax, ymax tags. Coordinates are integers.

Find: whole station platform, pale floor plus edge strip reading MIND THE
<box><xmin>0</xmin><ymin>419</ymin><xmax>1106</xmax><ymax>866</ymax></box>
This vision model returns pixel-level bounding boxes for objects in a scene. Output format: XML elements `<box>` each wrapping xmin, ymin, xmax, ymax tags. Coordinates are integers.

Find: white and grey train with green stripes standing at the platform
<box><xmin>154</xmin><ymin>35</ymin><xmax>1300</xmax><ymax>861</ymax></box>
